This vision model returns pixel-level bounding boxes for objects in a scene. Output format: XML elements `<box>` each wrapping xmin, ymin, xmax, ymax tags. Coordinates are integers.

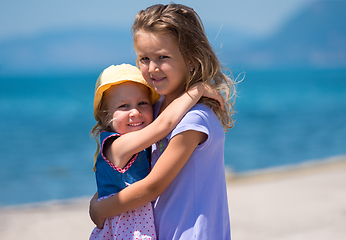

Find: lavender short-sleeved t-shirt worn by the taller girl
<box><xmin>152</xmin><ymin>96</ymin><xmax>231</xmax><ymax>240</ymax></box>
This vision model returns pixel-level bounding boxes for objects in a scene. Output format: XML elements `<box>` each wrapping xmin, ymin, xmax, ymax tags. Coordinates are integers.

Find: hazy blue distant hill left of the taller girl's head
<box><xmin>0</xmin><ymin>29</ymin><xmax>136</xmax><ymax>75</ymax></box>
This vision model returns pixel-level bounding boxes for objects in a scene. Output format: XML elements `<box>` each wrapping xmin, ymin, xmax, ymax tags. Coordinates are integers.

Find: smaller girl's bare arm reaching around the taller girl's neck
<box><xmin>107</xmin><ymin>83</ymin><xmax>223</xmax><ymax>168</ymax></box>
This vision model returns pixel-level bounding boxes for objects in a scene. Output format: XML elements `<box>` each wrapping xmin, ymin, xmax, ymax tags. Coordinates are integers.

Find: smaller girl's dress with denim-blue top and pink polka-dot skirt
<box><xmin>89</xmin><ymin>132</ymin><xmax>156</xmax><ymax>240</ymax></box>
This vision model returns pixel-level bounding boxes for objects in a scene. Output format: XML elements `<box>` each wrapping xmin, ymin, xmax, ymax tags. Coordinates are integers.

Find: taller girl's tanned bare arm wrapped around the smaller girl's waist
<box><xmin>90</xmin><ymin>130</ymin><xmax>207</xmax><ymax>228</ymax></box>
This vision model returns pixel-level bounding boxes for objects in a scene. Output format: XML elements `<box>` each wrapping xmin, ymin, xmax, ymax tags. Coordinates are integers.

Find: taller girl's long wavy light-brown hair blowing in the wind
<box><xmin>132</xmin><ymin>3</ymin><xmax>236</xmax><ymax>131</ymax></box>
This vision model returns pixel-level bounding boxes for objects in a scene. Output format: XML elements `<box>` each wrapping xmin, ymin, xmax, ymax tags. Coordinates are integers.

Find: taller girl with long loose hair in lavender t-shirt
<box><xmin>90</xmin><ymin>4</ymin><xmax>235</xmax><ymax>240</ymax></box>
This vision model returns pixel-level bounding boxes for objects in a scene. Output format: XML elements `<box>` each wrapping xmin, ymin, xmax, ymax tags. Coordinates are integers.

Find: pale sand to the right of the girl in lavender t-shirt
<box><xmin>228</xmin><ymin>158</ymin><xmax>346</xmax><ymax>240</ymax></box>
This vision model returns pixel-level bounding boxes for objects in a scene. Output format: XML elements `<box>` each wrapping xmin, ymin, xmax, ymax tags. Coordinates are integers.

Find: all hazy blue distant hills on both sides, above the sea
<box><xmin>0</xmin><ymin>1</ymin><xmax>346</xmax><ymax>75</ymax></box>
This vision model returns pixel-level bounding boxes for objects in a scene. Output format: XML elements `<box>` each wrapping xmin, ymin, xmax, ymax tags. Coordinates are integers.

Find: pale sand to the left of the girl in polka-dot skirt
<box><xmin>0</xmin><ymin>198</ymin><xmax>94</xmax><ymax>240</ymax></box>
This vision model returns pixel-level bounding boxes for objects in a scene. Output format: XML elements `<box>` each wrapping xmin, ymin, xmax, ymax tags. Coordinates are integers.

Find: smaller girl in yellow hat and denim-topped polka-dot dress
<box><xmin>90</xmin><ymin>64</ymin><xmax>222</xmax><ymax>239</ymax></box>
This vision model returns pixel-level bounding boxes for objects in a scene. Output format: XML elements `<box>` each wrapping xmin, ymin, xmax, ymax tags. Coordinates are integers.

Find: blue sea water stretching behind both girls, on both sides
<box><xmin>0</xmin><ymin>70</ymin><xmax>346</xmax><ymax>205</ymax></box>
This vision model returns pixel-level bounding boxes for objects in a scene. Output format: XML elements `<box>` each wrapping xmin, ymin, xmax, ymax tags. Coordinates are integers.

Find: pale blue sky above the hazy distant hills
<box><xmin>0</xmin><ymin>0</ymin><xmax>312</xmax><ymax>41</ymax></box>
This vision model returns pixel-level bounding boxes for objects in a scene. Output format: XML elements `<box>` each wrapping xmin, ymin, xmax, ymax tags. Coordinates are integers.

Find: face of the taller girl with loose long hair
<box><xmin>135</xmin><ymin>30</ymin><xmax>188</xmax><ymax>101</ymax></box>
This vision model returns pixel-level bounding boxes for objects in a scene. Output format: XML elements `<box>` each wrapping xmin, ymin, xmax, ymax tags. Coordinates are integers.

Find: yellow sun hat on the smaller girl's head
<box><xmin>94</xmin><ymin>63</ymin><xmax>160</xmax><ymax>120</ymax></box>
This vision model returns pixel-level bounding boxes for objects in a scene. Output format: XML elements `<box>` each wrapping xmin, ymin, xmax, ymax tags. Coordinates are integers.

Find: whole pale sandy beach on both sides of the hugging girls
<box><xmin>0</xmin><ymin>156</ymin><xmax>346</xmax><ymax>240</ymax></box>
